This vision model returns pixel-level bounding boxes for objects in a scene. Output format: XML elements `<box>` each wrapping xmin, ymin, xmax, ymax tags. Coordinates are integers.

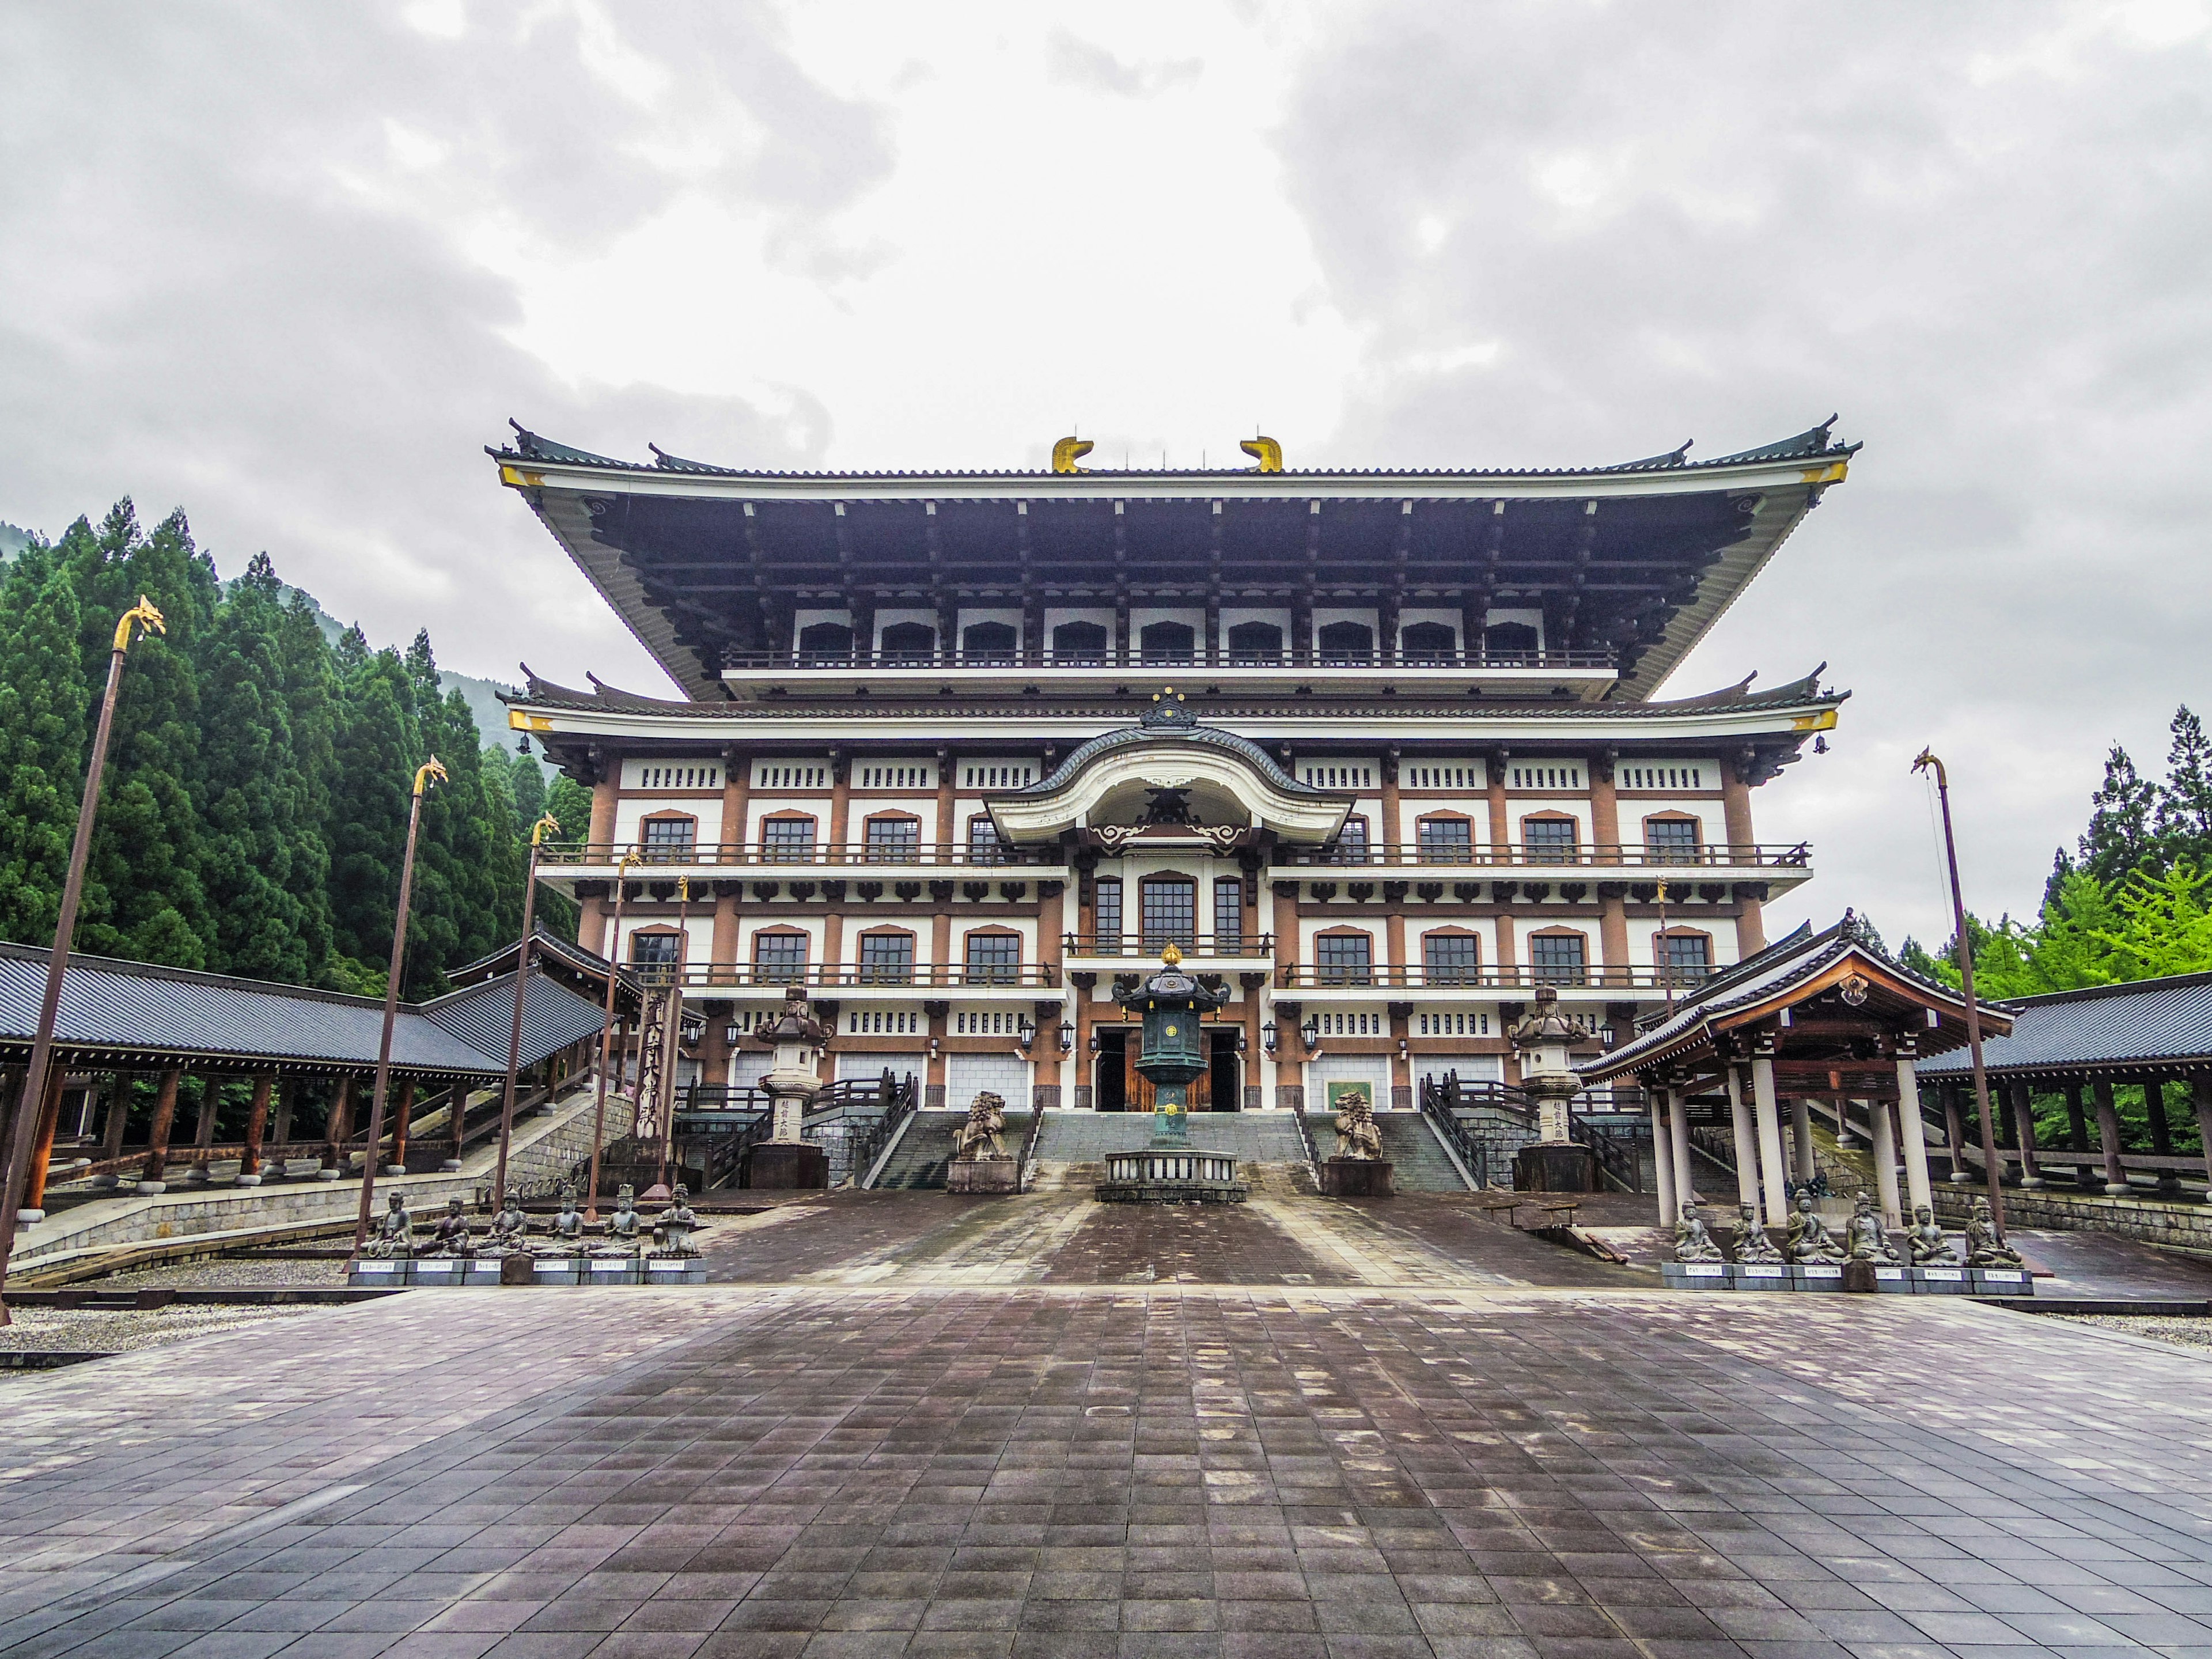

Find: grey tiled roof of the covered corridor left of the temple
<box><xmin>0</xmin><ymin>945</ymin><xmax>600</xmax><ymax>1077</ymax></box>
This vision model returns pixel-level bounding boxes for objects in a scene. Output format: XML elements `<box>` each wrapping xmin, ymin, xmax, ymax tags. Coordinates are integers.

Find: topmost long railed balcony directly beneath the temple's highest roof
<box><xmin>721</xmin><ymin>646</ymin><xmax>1619</xmax><ymax>701</ymax></box>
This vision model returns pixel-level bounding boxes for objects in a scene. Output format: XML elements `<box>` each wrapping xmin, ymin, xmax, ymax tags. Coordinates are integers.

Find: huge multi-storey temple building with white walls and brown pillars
<box><xmin>491</xmin><ymin>421</ymin><xmax>1856</xmax><ymax>1113</ymax></box>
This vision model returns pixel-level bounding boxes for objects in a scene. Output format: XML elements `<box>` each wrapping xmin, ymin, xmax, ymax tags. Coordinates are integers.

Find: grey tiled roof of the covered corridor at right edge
<box><xmin>1914</xmin><ymin>974</ymin><xmax>2212</xmax><ymax>1077</ymax></box>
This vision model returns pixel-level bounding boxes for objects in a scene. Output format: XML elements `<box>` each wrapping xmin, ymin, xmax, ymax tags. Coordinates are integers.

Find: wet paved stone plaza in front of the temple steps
<box><xmin>0</xmin><ymin>1192</ymin><xmax>2212</xmax><ymax>1659</ymax></box>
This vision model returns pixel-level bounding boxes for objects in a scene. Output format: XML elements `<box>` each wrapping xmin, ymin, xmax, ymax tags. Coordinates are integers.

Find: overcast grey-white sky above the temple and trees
<box><xmin>0</xmin><ymin>0</ymin><xmax>2212</xmax><ymax>942</ymax></box>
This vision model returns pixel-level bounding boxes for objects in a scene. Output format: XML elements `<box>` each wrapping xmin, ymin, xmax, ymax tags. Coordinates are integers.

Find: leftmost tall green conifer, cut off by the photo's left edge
<box><xmin>0</xmin><ymin>542</ymin><xmax>86</xmax><ymax>945</ymax></box>
